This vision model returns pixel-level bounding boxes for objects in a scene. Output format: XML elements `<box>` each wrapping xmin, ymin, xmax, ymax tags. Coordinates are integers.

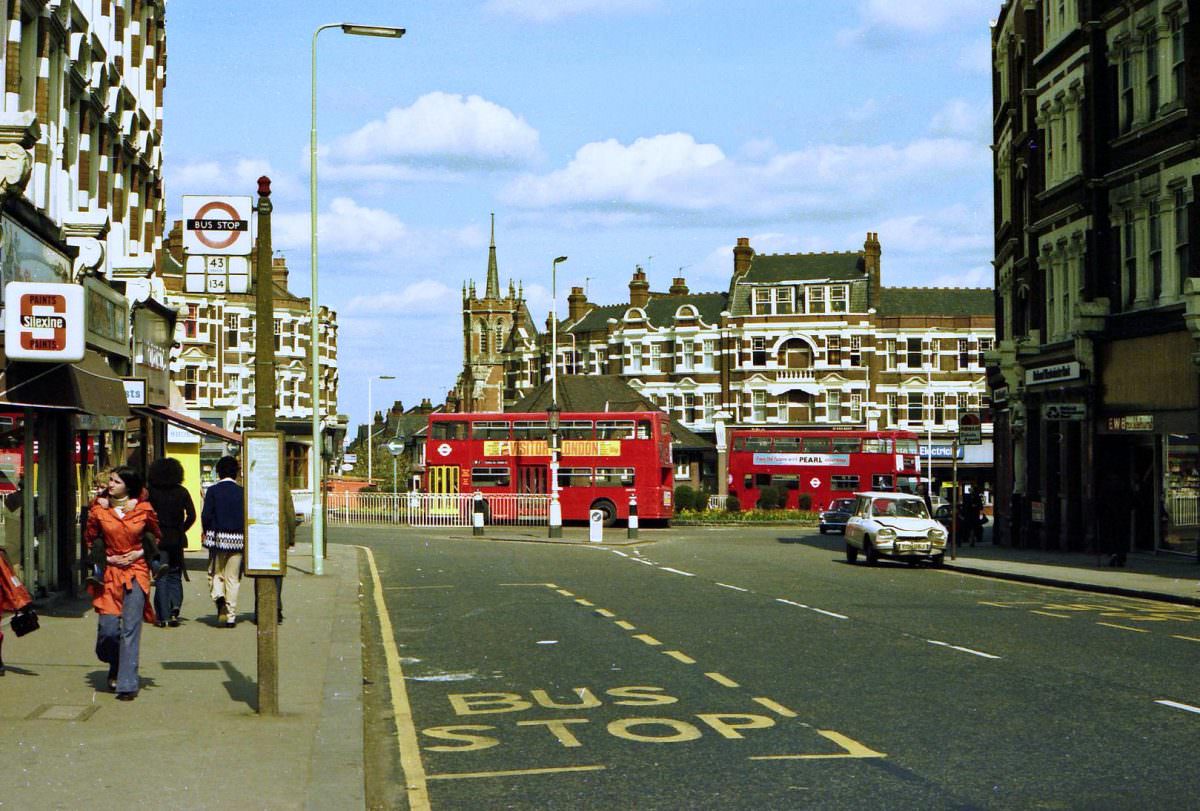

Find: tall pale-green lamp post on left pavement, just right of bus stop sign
<box><xmin>308</xmin><ymin>23</ymin><xmax>404</xmax><ymax>575</ymax></box>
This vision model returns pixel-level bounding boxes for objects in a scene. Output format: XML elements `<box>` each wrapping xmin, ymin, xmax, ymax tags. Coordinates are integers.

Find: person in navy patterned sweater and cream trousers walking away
<box><xmin>200</xmin><ymin>456</ymin><xmax>246</xmax><ymax>627</ymax></box>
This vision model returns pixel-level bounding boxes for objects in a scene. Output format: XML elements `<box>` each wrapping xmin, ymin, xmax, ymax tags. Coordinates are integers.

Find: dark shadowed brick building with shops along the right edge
<box><xmin>990</xmin><ymin>0</ymin><xmax>1200</xmax><ymax>554</ymax></box>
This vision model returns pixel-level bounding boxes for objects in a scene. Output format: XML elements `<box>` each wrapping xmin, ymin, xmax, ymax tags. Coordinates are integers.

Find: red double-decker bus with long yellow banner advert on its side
<box><xmin>424</xmin><ymin>411</ymin><xmax>674</xmax><ymax>525</ymax></box>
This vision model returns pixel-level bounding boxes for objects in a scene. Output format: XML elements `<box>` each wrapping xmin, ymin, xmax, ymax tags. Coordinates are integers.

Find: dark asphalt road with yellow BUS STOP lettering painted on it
<box><xmin>348</xmin><ymin>528</ymin><xmax>1200</xmax><ymax>809</ymax></box>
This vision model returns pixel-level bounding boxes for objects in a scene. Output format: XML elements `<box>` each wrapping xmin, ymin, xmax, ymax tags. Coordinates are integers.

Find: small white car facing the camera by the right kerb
<box><xmin>846</xmin><ymin>492</ymin><xmax>946</xmax><ymax>566</ymax></box>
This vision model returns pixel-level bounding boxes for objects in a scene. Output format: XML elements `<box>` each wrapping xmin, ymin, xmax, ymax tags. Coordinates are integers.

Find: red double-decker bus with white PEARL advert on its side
<box><xmin>730</xmin><ymin>429</ymin><xmax>920</xmax><ymax>510</ymax></box>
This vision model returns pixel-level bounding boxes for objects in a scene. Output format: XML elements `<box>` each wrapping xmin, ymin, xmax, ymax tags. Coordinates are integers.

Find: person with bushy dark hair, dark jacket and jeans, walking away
<box><xmin>146</xmin><ymin>457</ymin><xmax>196</xmax><ymax>627</ymax></box>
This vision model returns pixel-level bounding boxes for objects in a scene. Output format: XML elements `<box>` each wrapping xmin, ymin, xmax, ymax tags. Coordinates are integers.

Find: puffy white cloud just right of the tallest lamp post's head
<box><xmin>322</xmin><ymin>91</ymin><xmax>539</xmax><ymax>169</ymax></box>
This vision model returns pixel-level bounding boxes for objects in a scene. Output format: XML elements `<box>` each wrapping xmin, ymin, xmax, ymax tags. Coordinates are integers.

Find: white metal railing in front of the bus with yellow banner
<box><xmin>325</xmin><ymin>493</ymin><xmax>550</xmax><ymax>527</ymax></box>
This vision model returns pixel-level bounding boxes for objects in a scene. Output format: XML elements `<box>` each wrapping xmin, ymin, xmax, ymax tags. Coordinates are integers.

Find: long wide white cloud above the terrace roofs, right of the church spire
<box><xmin>502</xmin><ymin>133</ymin><xmax>990</xmax><ymax>226</ymax></box>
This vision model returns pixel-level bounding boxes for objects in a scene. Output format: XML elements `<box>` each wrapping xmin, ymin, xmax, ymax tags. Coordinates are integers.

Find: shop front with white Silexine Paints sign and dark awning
<box><xmin>0</xmin><ymin>206</ymin><xmax>128</xmax><ymax>594</ymax></box>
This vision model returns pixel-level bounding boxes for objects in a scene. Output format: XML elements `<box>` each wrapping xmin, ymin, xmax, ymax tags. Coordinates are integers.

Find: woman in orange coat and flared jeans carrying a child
<box><xmin>84</xmin><ymin>467</ymin><xmax>160</xmax><ymax>701</ymax></box>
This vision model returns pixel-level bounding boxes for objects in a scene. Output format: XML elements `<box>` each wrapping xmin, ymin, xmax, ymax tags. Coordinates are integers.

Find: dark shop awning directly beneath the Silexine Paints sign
<box><xmin>0</xmin><ymin>349</ymin><xmax>130</xmax><ymax>417</ymax></box>
